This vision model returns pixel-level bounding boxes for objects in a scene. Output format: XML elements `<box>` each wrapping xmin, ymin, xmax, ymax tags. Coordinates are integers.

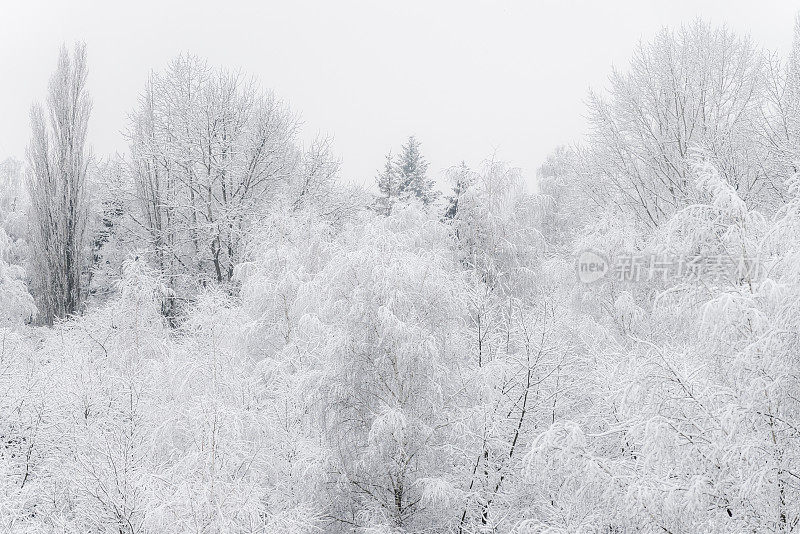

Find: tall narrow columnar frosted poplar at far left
<box><xmin>27</xmin><ymin>45</ymin><xmax>92</xmax><ymax>324</ymax></box>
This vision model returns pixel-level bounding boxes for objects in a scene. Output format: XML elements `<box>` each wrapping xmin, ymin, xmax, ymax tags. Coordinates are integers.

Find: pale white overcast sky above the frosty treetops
<box><xmin>0</xmin><ymin>0</ymin><xmax>800</xmax><ymax>191</ymax></box>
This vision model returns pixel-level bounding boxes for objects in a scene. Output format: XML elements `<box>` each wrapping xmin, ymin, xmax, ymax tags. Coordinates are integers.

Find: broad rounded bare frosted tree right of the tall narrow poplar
<box><xmin>128</xmin><ymin>56</ymin><xmax>301</xmax><ymax>300</ymax></box>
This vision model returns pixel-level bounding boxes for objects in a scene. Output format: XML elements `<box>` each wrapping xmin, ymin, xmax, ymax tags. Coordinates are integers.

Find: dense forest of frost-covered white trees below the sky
<box><xmin>0</xmin><ymin>19</ymin><xmax>800</xmax><ymax>534</ymax></box>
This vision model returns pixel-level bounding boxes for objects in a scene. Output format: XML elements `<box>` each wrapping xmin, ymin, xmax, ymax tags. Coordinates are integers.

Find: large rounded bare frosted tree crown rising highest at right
<box><xmin>588</xmin><ymin>20</ymin><xmax>782</xmax><ymax>227</ymax></box>
